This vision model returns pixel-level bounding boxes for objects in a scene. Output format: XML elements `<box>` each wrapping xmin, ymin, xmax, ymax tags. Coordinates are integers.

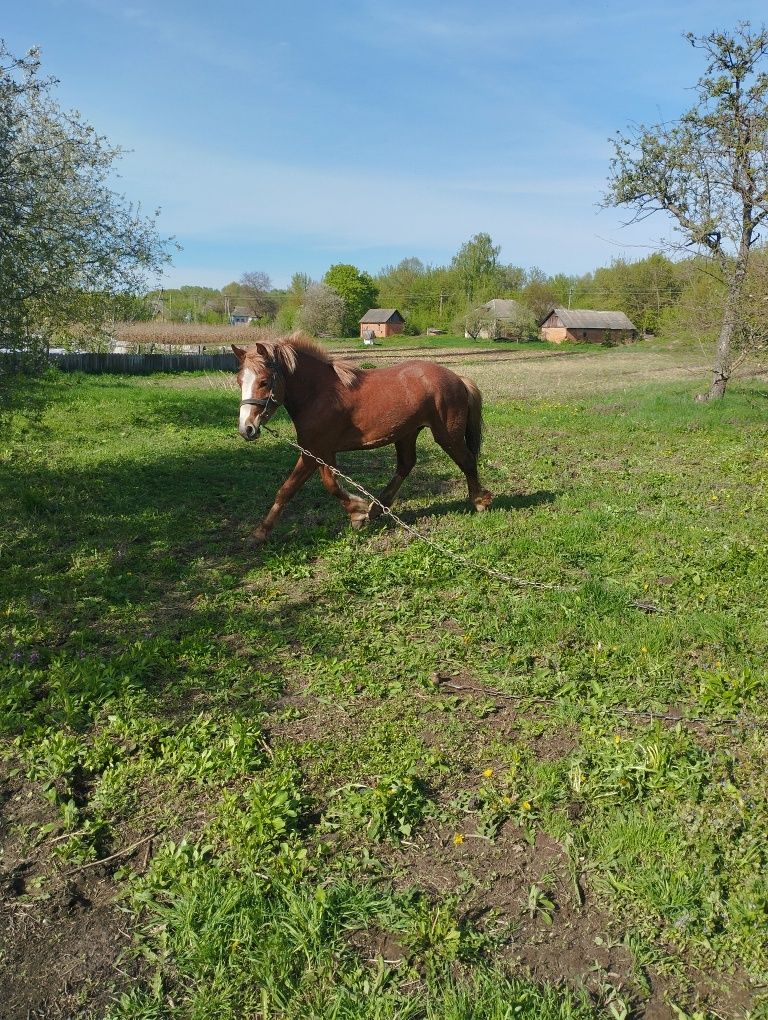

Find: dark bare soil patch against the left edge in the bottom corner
<box><xmin>0</xmin><ymin>779</ymin><xmax>136</xmax><ymax>1020</ymax></box>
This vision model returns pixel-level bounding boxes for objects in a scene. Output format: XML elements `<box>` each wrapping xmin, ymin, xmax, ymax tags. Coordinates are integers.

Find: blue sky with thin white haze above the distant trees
<box><xmin>7</xmin><ymin>0</ymin><xmax>766</xmax><ymax>287</ymax></box>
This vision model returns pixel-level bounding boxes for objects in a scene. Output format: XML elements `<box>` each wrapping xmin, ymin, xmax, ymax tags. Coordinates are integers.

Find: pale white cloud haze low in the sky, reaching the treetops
<box><xmin>118</xmin><ymin>135</ymin><xmax>648</xmax><ymax>279</ymax></box>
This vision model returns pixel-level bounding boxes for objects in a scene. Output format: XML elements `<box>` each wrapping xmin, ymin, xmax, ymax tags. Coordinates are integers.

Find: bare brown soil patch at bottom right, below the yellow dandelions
<box><xmin>375</xmin><ymin>822</ymin><xmax>673</xmax><ymax>1020</ymax></box>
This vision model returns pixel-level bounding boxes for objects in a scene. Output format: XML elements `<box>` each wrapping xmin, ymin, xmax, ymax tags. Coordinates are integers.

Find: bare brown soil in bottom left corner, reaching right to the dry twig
<box><xmin>0</xmin><ymin>777</ymin><xmax>217</xmax><ymax>1020</ymax></box>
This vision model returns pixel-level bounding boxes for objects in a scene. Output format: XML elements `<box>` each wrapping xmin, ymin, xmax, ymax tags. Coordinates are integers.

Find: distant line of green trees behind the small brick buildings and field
<box><xmin>143</xmin><ymin>234</ymin><xmax>768</xmax><ymax>350</ymax></box>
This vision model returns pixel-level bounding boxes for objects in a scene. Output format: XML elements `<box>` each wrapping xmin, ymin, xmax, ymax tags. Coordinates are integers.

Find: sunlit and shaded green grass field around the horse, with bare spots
<box><xmin>0</xmin><ymin>347</ymin><xmax>768</xmax><ymax>1020</ymax></box>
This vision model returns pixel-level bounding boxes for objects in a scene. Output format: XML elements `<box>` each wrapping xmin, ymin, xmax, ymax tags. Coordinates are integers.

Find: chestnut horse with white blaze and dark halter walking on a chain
<box><xmin>233</xmin><ymin>335</ymin><xmax>492</xmax><ymax>543</ymax></box>
